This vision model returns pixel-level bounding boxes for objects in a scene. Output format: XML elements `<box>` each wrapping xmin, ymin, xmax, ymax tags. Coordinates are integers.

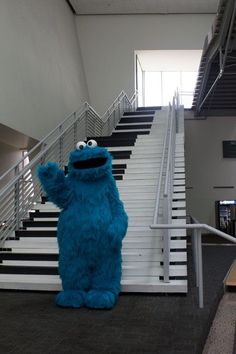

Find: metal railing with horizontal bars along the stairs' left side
<box><xmin>0</xmin><ymin>91</ymin><xmax>137</xmax><ymax>247</ymax></box>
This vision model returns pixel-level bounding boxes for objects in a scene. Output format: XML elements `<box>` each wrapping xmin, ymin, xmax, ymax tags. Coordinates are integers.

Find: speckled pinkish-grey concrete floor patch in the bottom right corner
<box><xmin>203</xmin><ymin>293</ymin><xmax>236</xmax><ymax>354</ymax></box>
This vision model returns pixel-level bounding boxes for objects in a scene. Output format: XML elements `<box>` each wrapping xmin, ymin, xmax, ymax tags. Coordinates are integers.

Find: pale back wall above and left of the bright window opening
<box><xmin>76</xmin><ymin>14</ymin><xmax>214</xmax><ymax>113</ymax></box>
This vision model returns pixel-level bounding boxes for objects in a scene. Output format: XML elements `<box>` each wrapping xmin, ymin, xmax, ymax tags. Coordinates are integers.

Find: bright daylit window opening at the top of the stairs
<box><xmin>136</xmin><ymin>50</ymin><xmax>201</xmax><ymax>108</ymax></box>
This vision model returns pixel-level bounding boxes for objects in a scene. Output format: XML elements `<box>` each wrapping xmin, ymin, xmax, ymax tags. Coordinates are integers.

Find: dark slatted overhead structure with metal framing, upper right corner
<box><xmin>192</xmin><ymin>0</ymin><xmax>236</xmax><ymax>117</ymax></box>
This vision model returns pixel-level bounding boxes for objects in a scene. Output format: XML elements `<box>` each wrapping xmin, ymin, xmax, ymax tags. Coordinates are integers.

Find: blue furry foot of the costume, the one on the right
<box><xmin>85</xmin><ymin>290</ymin><xmax>116</xmax><ymax>309</ymax></box>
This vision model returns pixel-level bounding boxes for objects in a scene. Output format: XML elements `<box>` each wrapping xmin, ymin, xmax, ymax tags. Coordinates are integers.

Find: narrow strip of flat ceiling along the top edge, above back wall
<box><xmin>67</xmin><ymin>0</ymin><xmax>219</xmax><ymax>15</ymax></box>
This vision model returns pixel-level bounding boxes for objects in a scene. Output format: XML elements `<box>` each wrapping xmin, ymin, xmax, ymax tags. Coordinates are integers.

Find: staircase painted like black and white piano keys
<box><xmin>0</xmin><ymin>100</ymin><xmax>187</xmax><ymax>293</ymax></box>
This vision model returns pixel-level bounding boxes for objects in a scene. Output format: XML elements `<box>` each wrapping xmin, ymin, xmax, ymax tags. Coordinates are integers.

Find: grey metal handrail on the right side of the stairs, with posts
<box><xmin>150</xmin><ymin>94</ymin><xmax>236</xmax><ymax>308</ymax></box>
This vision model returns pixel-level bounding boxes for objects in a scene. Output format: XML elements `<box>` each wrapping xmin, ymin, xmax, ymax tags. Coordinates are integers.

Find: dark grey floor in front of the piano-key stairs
<box><xmin>0</xmin><ymin>245</ymin><xmax>236</xmax><ymax>354</ymax></box>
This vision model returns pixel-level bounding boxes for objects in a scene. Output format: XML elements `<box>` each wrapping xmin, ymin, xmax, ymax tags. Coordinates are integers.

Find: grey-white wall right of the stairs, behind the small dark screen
<box><xmin>185</xmin><ymin>117</ymin><xmax>236</xmax><ymax>226</ymax></box>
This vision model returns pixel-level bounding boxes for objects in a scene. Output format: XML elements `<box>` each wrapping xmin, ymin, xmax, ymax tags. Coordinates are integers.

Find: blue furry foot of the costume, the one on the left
<box><xmin>56</xmin><ymin>290</ymin><xmax>85</xmax><ymax>308</ymax></box>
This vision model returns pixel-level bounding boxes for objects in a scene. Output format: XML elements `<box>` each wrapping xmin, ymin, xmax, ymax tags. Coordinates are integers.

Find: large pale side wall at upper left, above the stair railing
<box><xmin>0</xmin><ymin>0</ymin><xmax>88</xmax><ymax>139</ymax></box>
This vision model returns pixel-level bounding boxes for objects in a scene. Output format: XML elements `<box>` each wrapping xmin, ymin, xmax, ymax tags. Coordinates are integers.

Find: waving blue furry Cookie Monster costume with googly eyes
<box><xmin>38</xmin><ymin>140</ymin><xmax>128</xmax><ymax>309</ymax></box>
